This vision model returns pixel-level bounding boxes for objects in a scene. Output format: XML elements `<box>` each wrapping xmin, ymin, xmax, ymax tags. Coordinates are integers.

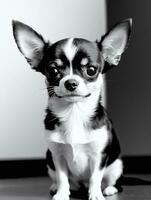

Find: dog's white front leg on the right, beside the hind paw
<box><xmin>89</xmin><ymin>156</ymin><xmax>104</xmax><ymax>200</ymax></box>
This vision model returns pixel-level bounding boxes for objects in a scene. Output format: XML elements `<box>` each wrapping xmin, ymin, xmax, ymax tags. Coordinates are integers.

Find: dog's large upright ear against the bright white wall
<box><xmin>12</xmin><ymin>20</ymin><xmax>46</xmax><ymax>71</ymax></box>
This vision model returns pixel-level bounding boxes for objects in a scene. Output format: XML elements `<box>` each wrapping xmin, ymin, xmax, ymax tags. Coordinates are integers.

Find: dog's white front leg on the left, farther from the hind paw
<box><xmin>52</xmin><ymin>154</ymin><xmax>70</xmax><ymax>200</ymax></box>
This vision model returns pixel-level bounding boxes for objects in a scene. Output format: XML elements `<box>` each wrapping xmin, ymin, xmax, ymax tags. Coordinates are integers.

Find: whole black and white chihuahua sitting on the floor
<box><xmin>13</xmin><ymin>19</ymin><xmax>132</xmax><ymax>200</ymax></box>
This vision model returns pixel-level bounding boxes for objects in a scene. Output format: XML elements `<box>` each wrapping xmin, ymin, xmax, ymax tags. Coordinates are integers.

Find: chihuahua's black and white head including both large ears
<box><xmin>13</xmin><ymin>19</ymin><xmax>132</xmax><ymax>101</ymax></box>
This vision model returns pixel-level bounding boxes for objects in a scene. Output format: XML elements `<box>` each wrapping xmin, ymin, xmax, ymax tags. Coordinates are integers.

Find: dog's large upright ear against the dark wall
<box><xmin>99</xmin><ymin>19</ymin><xmax>132</xmax><ymax>73</ymax></box>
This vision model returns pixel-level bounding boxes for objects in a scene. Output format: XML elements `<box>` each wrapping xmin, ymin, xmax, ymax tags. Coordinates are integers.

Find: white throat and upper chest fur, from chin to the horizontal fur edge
<box><xmin>48</xmin><ymin>91</ymin><xmax>100</xmax><ymax>144</ymax></box>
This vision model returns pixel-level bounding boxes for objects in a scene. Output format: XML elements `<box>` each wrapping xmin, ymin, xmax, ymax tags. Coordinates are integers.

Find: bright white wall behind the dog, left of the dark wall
<box><xmin>0</xmin><ymin>0</ymin><xmax>106</xmax><ymax>159</ymax></box>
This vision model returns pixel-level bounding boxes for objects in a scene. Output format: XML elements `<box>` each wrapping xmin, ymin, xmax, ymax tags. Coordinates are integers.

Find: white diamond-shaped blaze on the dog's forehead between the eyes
<box><xmin>64</xmin><ymin>38</ymin><xmax>77</xmax><ymax>63</ymax></box>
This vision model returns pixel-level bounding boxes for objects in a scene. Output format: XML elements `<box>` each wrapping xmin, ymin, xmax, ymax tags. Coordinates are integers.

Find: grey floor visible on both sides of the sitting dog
<box><xmin>0</xmin><ymin>175</ymin><xmax>151</xmax><ymax>200</ymax></box>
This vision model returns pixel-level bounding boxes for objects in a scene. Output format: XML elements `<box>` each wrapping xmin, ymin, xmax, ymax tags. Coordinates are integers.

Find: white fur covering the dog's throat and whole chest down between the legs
<box><xmin>46</xmin><ymin>93</ymin><xmax>109</xmax><ymax>176</ymax></box>
